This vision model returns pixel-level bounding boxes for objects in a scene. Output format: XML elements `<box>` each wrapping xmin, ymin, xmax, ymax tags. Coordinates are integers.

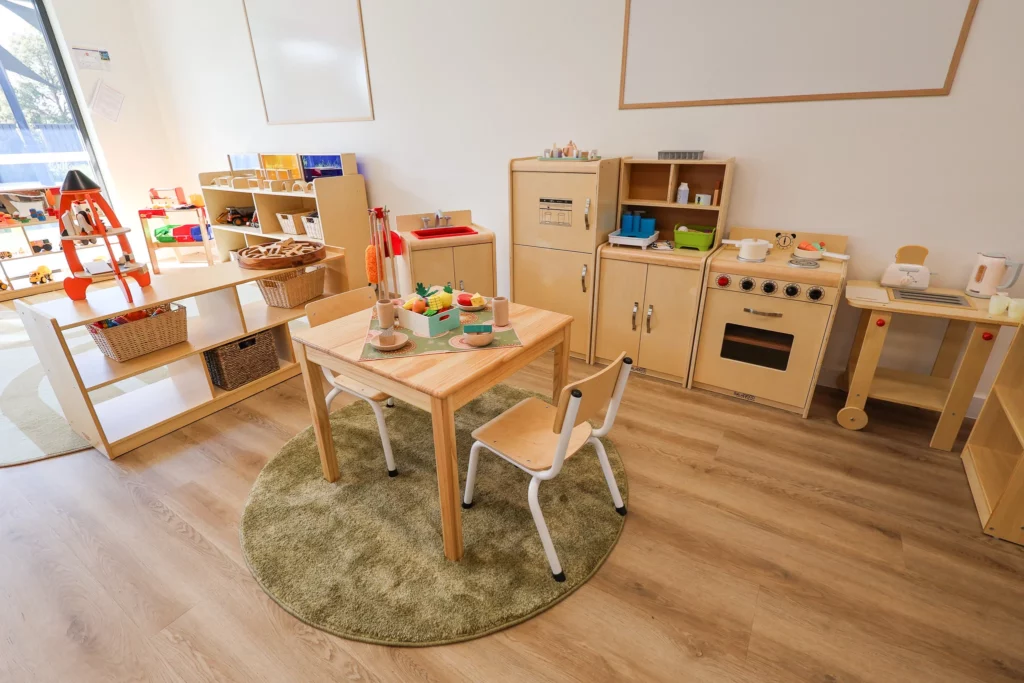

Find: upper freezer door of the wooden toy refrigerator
<box><xmin>512</xmin><ymin>171</ymin><xmax>597</xmax><ymax>252</ymax></box>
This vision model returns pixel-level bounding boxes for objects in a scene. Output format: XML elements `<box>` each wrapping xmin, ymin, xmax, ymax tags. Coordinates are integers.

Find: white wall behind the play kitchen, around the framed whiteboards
<box><xmin>52</xmin><ymin>0</ymin><xmax>1024</xmax><ymax>397</ymax></box>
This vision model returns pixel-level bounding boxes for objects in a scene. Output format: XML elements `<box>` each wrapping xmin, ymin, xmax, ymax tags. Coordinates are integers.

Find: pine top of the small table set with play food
<box><xmin>292</xmin><ymin>303</ymin><xmax>572</xmax><ymax>398</ymax></box>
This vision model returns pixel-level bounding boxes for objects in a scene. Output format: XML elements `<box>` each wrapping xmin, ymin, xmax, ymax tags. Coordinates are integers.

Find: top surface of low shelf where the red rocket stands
<box><xmin>18</xmin><ymin>243</ymin><xmax>345</xmax><ymax>330</ymax></box>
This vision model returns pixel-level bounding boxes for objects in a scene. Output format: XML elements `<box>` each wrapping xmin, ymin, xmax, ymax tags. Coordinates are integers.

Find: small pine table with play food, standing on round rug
<box><xmin>293</xmin><ymin>303</ymin><xmax>572</xmax><ymax>560</ymax></box>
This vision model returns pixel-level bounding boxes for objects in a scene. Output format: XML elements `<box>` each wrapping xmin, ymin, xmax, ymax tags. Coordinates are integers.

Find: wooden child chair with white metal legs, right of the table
<box><xmin>462</xmin><ymin>353</ymin><xmax>633</xmax><ymax>582</ymax></box>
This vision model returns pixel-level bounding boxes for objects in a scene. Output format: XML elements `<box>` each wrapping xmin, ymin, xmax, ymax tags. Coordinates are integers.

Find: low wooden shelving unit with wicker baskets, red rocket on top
<box><xmin>15</xmin><ymin>248</ymin><xmax>347</xmax><ymax>459</ymax></box>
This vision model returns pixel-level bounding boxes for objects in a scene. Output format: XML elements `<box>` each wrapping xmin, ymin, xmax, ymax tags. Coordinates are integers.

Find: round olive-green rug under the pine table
<box><xmin>239</xmin><ymin>385</ymin><xmax>628</xmax><ymax>645</ymax></box>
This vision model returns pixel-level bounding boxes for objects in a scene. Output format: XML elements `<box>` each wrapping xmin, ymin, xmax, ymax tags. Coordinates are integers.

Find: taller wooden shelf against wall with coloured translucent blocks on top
<box><xmin>199</xmin><ymin>154</ymin><xmax>370</xmax><ymax>290</ymax></box>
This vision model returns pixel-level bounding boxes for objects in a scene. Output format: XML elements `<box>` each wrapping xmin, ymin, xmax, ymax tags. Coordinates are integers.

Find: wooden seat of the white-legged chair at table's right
<box><xmin>473</xmin><ymin>398</ymin><xmax>593</xmax><ymax>472</ymax></box>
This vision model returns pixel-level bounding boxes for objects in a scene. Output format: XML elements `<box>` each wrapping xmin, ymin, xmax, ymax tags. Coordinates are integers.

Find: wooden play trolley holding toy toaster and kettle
<box><xmin>837</xmin><ymin>281</ymin><xmax>1019</xmax><ymax>451</ymax></box>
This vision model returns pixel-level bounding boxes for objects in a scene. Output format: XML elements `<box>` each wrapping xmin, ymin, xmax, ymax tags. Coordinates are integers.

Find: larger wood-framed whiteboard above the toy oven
<box><xmin>618</xmin><ymin>0</ymin><xmax>978</xmax><ymax>109</ymax></box>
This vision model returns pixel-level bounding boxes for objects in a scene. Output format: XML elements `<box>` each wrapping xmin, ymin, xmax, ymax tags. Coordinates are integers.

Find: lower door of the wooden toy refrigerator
<box><xmin>512</xmin><ymin>245</ymin><xmax>594</xmax><ymax>358</ymax></box>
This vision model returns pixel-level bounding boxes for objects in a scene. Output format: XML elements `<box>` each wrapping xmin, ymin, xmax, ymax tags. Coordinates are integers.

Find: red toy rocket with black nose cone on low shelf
<box><xmin>57</xmin><ymin>171</ymin><xmax>151</xmax><ymax>303</ymax></box>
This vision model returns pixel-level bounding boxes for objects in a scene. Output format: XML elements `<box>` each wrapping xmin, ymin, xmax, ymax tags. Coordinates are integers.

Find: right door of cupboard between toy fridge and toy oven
<box><xmin>638</xmin><ymin>265</ymin><xmax>700</xmax><ymax>382</ymax></box>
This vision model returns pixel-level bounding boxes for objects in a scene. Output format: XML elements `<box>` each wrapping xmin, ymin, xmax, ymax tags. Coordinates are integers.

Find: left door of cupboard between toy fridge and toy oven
<box><xmin>594</xmin><ymin>258</ymin><xmax>647</xmax><ymax>362</ymax></box>
